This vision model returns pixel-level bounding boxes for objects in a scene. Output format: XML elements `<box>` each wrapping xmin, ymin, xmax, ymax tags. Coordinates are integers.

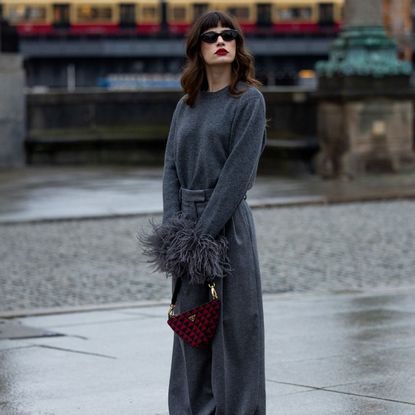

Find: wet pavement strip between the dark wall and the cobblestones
<box><xmin>0</xmin><ymin>166</ymin><xmax>415</xmax><ymax>223</ymax></box>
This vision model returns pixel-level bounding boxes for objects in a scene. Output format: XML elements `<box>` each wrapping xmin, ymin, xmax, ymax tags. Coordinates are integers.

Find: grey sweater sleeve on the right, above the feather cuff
<box><xmin>196</xmin><ymin>88</ymin><xmax>266</xmax><ymax>238</ymax></box>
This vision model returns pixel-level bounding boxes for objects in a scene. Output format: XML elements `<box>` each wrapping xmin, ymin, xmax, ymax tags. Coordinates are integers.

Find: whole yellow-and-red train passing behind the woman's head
<box><xmin>0</xmin><ymin>0</ymin><xmax>343</xmax><ymax>36</ymax></box>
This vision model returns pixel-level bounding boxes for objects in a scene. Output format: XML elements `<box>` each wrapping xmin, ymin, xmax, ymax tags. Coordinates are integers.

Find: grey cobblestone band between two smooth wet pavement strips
<box><xmin>0</xmin><ymin>200</ymin><xmax>415</xmax><ymax>311</ymax></box>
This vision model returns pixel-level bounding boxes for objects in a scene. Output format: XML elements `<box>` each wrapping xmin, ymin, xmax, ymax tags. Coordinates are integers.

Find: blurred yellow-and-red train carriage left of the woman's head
<box><xmin>2</xmin><ymin>0</ymin><xmax>161</xmax><ymax>36</ymax></box>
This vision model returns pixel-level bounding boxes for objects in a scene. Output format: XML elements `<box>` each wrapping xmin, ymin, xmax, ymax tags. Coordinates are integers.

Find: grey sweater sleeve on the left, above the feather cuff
<box><xmin>163</xmin><ymin>99</ymin><xmax>182</xmax><ymax>223</ymax></box>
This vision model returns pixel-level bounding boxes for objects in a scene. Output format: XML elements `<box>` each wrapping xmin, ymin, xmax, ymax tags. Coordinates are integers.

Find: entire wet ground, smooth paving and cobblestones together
<box><xmin>0</xmin><ymin>167</ymin><xmax>415</xmax><ymax>415</ymax></box>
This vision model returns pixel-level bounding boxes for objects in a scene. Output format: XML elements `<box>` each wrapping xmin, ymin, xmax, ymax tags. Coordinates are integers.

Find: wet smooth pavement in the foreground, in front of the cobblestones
<box><xmin>0</xmin><ymin>288</ymin><xmax>415</xmax><ymax>415</ymax></box>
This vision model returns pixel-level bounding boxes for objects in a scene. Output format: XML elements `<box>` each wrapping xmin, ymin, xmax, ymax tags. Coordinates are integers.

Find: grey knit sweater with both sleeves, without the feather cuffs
<box><xmin>163</xmin><ymin>84</ymin><xmax>266</xmax><ymax>232</ymax></box>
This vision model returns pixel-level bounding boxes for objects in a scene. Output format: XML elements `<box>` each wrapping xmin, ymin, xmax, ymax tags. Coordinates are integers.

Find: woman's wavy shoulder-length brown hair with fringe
<box><xmin>180</xmin><ymin>11</ymin><xmax>262</xmax><ymax>106</ymax></box>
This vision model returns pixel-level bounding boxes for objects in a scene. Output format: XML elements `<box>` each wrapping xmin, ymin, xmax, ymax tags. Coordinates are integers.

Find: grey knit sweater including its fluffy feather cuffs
<box><xmin>143</xmin><ymin>82</ymin><xmax>266</xmax><ymax>282</ymax></box>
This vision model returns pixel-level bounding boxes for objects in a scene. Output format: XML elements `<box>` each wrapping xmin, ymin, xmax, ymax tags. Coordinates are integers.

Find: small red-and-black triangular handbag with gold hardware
<box><xmin>167</xmin><ymin>278</ymin><xmax>221</xmax><ymax>348</ymax></box>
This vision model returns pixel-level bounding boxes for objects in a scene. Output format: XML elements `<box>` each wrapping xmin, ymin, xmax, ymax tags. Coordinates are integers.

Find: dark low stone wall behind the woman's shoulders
<box><xmin>26</xmin><ymin>88</ymin><xmax>316</xmax><ymax>170</ymax></box>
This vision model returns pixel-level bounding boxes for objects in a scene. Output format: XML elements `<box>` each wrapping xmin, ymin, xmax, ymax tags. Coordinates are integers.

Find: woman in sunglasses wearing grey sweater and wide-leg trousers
<box><xmin>143</xmin><ymin>12</ymin><xmax>266</xmax><ymax>415</ymax></box>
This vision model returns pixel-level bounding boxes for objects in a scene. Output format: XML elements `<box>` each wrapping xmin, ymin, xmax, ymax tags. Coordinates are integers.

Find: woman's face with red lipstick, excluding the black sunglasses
<box><xmin>200</xmin><ymin>26</ymin><xmax>236</xmax><ymax>65</ymax></box>
